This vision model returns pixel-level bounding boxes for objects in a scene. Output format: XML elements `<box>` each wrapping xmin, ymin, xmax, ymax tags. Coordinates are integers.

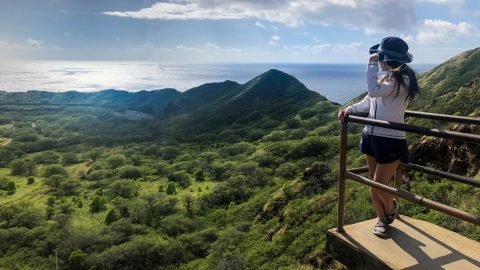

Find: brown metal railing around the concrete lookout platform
<box><xmin>337</xmin><ymin>111</ymin><xmax>480</xmax><ymax>232</ymax></box>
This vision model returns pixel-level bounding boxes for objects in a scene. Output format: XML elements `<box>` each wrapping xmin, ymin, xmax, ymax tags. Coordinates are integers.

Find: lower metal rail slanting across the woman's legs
<box><xmin>345</xmin><ymin>171</ymin><xmax>480</xmax><ymax>225</ymax></box>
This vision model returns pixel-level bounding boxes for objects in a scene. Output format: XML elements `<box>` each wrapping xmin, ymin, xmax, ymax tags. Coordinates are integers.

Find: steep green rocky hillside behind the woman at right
<box><xmin>410</xmin><ymin>48</ymin><xmax>480</xmax><ymax>176</ymax></box>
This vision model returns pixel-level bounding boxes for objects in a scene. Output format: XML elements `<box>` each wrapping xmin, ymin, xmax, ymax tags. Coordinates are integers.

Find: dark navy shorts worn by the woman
<box><xmin>360</xmin><ymin>130</ymin><xmax>408</xmax><ymax>163</ymax></box>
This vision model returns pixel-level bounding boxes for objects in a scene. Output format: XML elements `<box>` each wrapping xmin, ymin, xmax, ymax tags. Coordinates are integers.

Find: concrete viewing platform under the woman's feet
<box><xmin>327</xmin><ymin>216</ymin><xmax>480</xmax><ymax>270</ymax></box>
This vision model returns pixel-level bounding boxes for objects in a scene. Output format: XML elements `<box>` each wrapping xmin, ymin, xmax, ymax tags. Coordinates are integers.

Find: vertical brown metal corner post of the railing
<box><xmin>337</xmin><ymin>120</ymin><xmax>348</xmax><ymax>232</ymax></box>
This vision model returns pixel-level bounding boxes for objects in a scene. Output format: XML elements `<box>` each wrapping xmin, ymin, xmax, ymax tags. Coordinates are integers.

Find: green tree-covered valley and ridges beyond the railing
<box><xmin>0</xmin><ymin>54</ymin><xmax>480</xmax><ymax>269</ymax></box>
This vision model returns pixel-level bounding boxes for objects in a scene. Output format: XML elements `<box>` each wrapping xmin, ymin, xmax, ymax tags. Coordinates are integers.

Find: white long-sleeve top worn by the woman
<box><xmin>346</xmin><ymin>64</ymin><xmax>409</xmax><ymax>139</ymax></box>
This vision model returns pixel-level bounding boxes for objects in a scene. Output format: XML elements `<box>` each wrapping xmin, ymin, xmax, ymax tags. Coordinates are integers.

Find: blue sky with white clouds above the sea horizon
<box><xmin>0</xmin><ymin>0</ymin><xmax>480</xmax><ymax>64</ymax></box>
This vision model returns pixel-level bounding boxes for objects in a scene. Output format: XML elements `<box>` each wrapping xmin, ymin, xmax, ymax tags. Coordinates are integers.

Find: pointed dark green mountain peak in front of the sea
<box><xmin>161</xmin><ymin>69</ymin><xmax>330</xmax><ymax>139</ymax></box>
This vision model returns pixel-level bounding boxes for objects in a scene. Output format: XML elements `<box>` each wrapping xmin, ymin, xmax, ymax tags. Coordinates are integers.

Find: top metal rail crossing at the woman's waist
<box><xmin>345</xmin><ymin>115</ymin><xmax>480</xmax><ymax>144</ymax></box>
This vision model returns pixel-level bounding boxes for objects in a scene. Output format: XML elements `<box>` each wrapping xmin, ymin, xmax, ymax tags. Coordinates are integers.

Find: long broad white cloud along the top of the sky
<box><xmin>103</xmin><ymin>0</ymin><xmax>416</xmax><ymax>32</ymax></box>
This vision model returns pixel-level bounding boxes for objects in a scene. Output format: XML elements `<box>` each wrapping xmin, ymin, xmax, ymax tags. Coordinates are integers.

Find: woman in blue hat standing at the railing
<box><xmin>338</xmin><ymin>37</ymin><xmax>419</xmax><ymax>236</ymax></box>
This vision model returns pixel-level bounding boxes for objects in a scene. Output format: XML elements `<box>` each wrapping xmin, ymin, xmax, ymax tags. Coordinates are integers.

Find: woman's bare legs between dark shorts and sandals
<box><xmin>371</xmin><ymin>160</ymin><xmax>400</xmax><ymax>218</ymax></box>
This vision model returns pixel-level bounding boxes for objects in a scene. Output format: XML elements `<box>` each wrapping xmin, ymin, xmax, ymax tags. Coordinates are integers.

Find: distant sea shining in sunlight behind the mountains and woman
<box><xmin>0</xmin><ymin>61</ymin><xmax>435</xmax><ymax>104</ymax></box>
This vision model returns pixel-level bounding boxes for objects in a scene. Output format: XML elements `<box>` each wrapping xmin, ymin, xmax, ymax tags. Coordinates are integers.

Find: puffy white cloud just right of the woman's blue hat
<box><xmin>415</xmin><ymin>19</ymin><xmax>477</xmax><ymax>45</ymax></box>
